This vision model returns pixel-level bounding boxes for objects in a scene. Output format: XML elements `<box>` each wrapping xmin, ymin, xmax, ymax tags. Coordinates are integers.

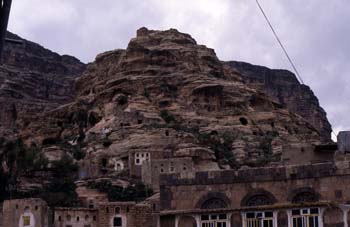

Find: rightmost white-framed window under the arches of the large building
<box><xmin>292</xmin><ymin>208</ymin><xmax>320</xmax><ymax>227</ymax></box>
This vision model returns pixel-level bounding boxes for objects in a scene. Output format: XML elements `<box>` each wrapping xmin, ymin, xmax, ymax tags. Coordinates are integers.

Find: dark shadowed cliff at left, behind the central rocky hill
<box><xmin>0</xmin><ymin>33</ymin><xmax>85</xmax><ymax>138</ymax></box>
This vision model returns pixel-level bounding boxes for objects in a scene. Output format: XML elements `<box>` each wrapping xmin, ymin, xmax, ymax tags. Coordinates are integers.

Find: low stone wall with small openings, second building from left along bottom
<box><xmin>54</xmin><ymin>208</ymin><xmax>98</xmax><ymax>227</ymax></box>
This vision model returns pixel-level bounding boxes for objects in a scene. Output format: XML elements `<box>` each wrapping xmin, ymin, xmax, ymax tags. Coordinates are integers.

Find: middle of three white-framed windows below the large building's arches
<box><xmin>245</xmin><ymin>211</ymin><xmax>273</xmax><ymax>227</ymax></box>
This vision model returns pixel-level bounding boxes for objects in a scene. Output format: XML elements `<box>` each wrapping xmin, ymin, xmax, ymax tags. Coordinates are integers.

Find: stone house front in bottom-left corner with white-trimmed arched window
<box><xmin>3</xmin><ymin>198</ymin><xmax>50</xmax><ymax>227</ymax></box>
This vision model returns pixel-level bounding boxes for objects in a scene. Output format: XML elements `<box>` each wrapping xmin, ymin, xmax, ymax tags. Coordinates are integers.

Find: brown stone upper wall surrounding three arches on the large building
<box><xmin>160</xmin><ymin>162</ymin><xmax>350</xmax><ymax>210</ymax></box>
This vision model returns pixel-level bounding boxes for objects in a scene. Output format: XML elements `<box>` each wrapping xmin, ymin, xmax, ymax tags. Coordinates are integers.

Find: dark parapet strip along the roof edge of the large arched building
<box><xmin>160</xmin><ymin>161</ymin><xmax>344</xmax><ymax>186</ymax></box>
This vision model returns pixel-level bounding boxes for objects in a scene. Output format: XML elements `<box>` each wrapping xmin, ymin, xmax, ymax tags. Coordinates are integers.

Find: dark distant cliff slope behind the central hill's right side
<box><xmin>225</xmin><ymin>61</ymin><xmax>332</xmax><ymax>142</ymax></box>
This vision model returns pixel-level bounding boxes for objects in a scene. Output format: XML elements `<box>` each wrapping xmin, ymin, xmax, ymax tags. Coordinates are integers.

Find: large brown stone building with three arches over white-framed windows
<box><xmin>160</xmin><ymin>161</ymin><xmax>350</xmax><ymax>227</ymax></box>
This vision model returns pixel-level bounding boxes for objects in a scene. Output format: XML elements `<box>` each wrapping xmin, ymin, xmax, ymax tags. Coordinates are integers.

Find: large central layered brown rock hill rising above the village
<box><xmin>21</xmin><ymin>28</ymin><xmax>321</xmax><ymax>175</ymax></box>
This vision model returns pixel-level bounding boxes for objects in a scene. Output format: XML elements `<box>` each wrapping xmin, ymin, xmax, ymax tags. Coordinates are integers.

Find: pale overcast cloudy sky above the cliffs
<box><xmin>9</xmin><ymin>0</ymin><xmax>350</xmax><ymax>139</ymax></box>
